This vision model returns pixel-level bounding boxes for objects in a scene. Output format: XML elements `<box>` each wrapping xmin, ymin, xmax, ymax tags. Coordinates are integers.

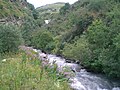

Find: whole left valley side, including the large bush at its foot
<box><xmin>0</xmin><ymin>0</ymin><xmax>37</xmax><ymax>52</ymax></box>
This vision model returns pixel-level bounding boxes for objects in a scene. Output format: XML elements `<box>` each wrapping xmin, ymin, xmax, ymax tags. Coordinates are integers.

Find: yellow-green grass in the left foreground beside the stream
<box><xmin>0</xmin><ymin>53</ymin><xmax>70</xmax><ymax>90</ymax></box>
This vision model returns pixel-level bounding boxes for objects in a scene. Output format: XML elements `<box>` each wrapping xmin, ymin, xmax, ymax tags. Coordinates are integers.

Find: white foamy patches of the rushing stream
<box><xmin>34</xmin><ymin>50</ymin><xmax>120</xmax><ymax>90</ymax></box>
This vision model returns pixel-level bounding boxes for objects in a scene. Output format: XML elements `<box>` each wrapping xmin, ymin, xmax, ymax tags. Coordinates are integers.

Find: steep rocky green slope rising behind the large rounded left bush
<box><xmin>0</xmin><ymin>0</ymin><xmax>38</xmax><ymax>48</ymax></box>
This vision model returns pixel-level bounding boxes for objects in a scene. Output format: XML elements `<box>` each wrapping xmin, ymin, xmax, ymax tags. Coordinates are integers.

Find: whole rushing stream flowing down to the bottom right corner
<box><xmin>34</xmin><ymin>51</ymin><xmax>120</xmax><ymax>90</ymax></box>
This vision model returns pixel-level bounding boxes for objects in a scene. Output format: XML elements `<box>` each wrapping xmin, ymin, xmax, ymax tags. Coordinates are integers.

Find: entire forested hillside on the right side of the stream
<box><xmin>33</xmin><ymin>0</ymin><xmax>120</xmax><ymax>78</ymax></box>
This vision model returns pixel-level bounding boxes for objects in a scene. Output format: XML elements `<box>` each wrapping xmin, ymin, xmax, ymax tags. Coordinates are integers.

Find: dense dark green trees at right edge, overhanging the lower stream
<box><xmin>86</xmin><ymin>19</ymin><xmax>120</xmax><ymax>77</ymax></box>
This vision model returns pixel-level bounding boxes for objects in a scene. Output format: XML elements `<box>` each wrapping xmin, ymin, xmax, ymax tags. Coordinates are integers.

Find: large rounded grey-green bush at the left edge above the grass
<box><xmin>0</xmin><ymin>25</ymin><xmax>22</xmax><ymax>53</ymax></box>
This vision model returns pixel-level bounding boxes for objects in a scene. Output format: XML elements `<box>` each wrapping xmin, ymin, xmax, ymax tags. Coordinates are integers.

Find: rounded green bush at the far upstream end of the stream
<box><xmin>32</xmin><ymin>31</ymin><xmax>55</xmax><ymax>51</ymax></box>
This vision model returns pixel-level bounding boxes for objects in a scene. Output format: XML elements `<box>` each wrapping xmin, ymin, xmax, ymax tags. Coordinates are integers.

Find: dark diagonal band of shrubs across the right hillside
<box><xmin>63</xmin><ymin>14</ymin><xmax>93</xmax><ymax>42</ymax></box>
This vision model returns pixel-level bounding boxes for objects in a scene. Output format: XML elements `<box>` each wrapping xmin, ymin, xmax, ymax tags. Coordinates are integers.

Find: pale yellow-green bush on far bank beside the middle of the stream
<box><xmin>63</xmin><ymin>36</ymin><xmax>90</xmax><ymax>62</ymax></box>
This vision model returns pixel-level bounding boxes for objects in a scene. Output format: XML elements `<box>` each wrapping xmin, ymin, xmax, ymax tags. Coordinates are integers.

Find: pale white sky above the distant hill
<box><xmin>27</xmin><ymin>0</ymin><xmax>78</xmax><ymax>8</ymax></box>
